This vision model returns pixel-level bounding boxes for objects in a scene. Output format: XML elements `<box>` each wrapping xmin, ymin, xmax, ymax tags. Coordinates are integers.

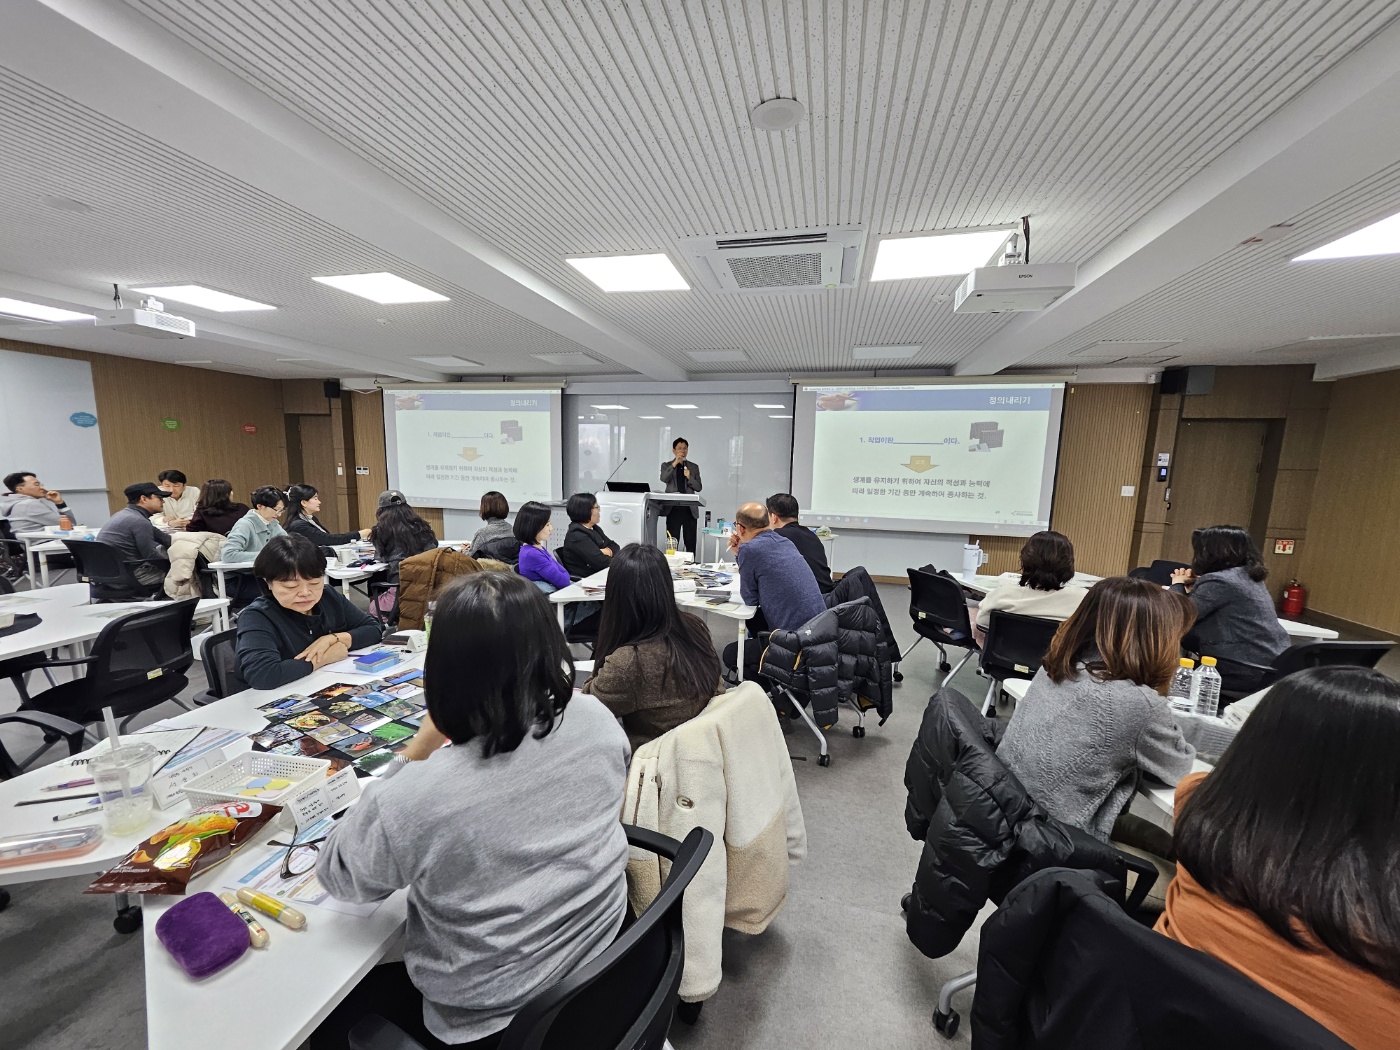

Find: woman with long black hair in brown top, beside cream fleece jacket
<box><xmin>584</xmin><ymin>543</ymin><xmax>724</xmax><ymax>748</ymax></box>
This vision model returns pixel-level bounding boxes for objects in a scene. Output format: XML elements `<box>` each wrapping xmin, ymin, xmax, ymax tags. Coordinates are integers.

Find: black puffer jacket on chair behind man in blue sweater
<box><xmin>759</xmin><ymin>598</ymin><xmax>879</xmax><ymax>729</ymax></box>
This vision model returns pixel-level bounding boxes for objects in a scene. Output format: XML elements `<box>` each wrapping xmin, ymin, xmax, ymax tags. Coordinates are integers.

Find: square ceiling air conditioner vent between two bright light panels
<box><xmin>679</xmin><ymin>225</ymin><xmax>865</xmax><ymax>295</ymax></box>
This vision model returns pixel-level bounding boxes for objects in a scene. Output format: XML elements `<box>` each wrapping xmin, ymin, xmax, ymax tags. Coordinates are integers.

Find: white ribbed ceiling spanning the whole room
<box><xmin>0</xmin><ymin>0</ymin><xmax>1400</xmax><ymax>379</ymax></box>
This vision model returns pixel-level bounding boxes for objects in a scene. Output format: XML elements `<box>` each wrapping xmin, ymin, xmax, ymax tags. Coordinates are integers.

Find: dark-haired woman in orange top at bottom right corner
<box><xmin>1156</xmin><ymin>666</ymin><xmax>1400</xmax><ymax>1050</ymax></box>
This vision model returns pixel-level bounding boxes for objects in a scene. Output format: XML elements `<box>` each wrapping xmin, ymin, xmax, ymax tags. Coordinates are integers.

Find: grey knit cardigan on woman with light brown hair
<box><xmin>997</xmin><ymin>664</ymin><xmax>1196</xmax><ymax>841</ymax></box>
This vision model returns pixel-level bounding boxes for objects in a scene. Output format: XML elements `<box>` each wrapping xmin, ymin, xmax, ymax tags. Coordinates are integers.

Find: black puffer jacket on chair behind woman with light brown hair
<box><xmin>904</xmin><ymin>689</ymin><xmax>1127</xmax><ymax>959</ymax></box>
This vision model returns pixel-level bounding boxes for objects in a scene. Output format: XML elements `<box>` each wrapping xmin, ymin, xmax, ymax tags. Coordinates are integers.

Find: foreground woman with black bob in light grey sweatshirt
<box><xmin>311</xmin><ymin>573</ymin><xmax>630</xmax><ymax>1050</ymax></box>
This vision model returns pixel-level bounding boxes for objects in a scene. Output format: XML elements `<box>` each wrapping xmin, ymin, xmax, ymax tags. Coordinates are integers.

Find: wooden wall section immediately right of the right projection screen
<box><xmin>979</xmin><ymin>384</ymin><xmax>1152</xmax><ymax>575</ymax></box>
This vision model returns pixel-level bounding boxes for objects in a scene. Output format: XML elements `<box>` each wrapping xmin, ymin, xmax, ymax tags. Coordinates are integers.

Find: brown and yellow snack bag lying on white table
<box><xmin>84</xmin><ymin>801</ymin><xmax>281</xmax><ymax>896</ymax></box>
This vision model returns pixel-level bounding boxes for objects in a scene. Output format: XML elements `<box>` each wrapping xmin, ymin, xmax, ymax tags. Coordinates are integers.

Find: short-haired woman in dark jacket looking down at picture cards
<box><xmin>238</xmin><ymin>535</ymin><xmax>384</xmax><ymax>689</ymax></box>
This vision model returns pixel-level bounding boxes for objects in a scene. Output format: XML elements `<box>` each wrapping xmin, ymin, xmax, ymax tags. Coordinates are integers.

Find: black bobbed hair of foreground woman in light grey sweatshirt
<box><xmin>420</xmin><ymin>571</ymin><xmax>574</xmax><ymax>759</ymax></box>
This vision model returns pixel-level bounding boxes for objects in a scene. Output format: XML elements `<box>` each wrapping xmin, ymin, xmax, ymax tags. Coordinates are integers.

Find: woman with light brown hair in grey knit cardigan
<box><xmin>997</xmin><ymin>577</ymin><xmax>1196</xmax><ymax>841</ymax></box>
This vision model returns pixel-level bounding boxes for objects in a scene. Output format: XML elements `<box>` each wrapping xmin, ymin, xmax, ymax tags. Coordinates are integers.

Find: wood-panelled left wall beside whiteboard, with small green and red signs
<box><xmin>0</xmin><ymin>339</ymin><xmax>287</xmax><ymax>511</ymax></box>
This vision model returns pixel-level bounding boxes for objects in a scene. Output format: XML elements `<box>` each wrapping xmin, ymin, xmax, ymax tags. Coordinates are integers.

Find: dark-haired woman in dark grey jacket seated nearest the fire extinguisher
<box><xmin>1172</xmin><ymin>525</ymin><xmax>1288</xmax><ymax>693</ymax></box>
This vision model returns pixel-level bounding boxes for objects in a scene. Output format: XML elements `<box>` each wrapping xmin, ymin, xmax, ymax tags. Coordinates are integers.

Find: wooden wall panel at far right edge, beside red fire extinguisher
<box><xmin>1293</xmin><ymin>371</ymin><xmax>1400</xmax><ymax>634</ymax></box>
